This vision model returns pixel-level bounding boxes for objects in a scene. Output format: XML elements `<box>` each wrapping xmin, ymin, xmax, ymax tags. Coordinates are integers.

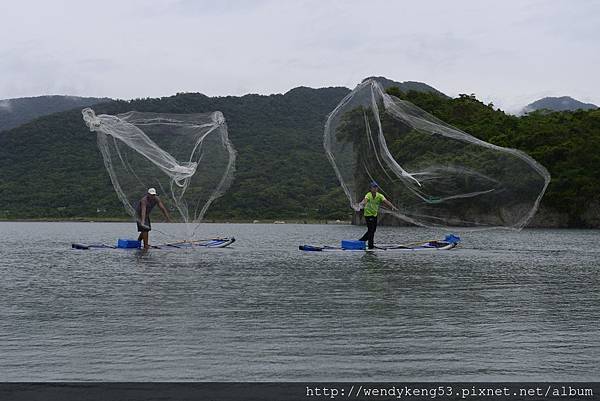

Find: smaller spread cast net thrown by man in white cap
<box><xmin>82</xmin><ymin>108</ymin><xmax>236</xmax><ymax>239</ymax></box>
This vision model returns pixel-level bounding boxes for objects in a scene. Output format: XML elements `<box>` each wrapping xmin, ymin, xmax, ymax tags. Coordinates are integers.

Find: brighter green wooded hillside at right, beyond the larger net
<box><xmin>389</xmin><ymin>89</ymin><xmax>600</xmax><ymax>227</ymax></box>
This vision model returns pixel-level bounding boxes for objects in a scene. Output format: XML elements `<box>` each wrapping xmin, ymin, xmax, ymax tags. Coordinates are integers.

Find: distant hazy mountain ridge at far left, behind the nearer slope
<box><xmin>0</xmin><ymin>95</ymin><xmax>111</xmax><ymax>131</ymax></box>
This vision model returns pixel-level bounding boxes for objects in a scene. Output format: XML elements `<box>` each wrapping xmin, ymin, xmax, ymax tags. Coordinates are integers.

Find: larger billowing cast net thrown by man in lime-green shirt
<box><xmin>324</xmin><ymin>80</ymin><xmax>550</xmax><ymax>229</ymax></box>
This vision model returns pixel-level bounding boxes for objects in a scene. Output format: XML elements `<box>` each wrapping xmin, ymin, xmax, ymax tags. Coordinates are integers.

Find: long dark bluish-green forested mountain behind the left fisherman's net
<box><xmin>0</xmin><ymin>88</ymin><xmax>349</xmax><ymax>219</ymax></box>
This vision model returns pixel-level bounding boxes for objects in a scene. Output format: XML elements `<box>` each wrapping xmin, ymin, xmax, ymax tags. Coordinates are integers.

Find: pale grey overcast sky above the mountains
<box><xmin>0</xmin><ymin>0</ymin><xmax>600</xmax><ymax>111</ymax></box>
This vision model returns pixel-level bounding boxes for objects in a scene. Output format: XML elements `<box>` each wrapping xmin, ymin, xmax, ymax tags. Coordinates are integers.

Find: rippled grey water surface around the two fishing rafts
<box><xmin>0</xmin><ymin>223</ymin><xmax>600</xmax><ymax>381</ymax></box>
